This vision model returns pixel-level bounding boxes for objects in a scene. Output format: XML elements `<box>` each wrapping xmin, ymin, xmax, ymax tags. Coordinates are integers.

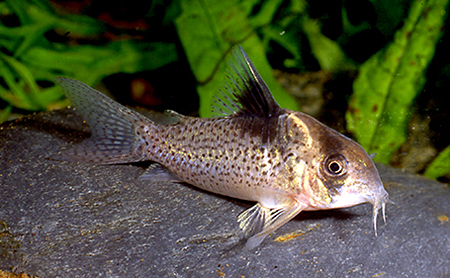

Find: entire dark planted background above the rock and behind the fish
<box><xmin>0</xmin><ymin>0</ymin><xmax>450</xmax><ymax>183</ymax></box>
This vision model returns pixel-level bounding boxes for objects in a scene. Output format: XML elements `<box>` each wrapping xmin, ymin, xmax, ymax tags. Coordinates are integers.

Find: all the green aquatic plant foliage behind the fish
<box><xmin>0</xmin><ymin>0</ymin><xmax>450</xmax><ymax>181</ymax></box>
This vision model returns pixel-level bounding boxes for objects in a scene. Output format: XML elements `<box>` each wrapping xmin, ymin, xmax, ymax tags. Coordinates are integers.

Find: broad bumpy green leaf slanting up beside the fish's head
<box><xmin>346</xmin><ymin>0</ymin><xmax>448</xmax><ymax>163</ymax></box>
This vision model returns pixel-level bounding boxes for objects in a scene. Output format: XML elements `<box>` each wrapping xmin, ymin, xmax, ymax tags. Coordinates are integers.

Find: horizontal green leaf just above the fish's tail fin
<box><xmin>21</xmin><ymin>41</ymin><xmax>178</xmax><ymax>84</ymax></box>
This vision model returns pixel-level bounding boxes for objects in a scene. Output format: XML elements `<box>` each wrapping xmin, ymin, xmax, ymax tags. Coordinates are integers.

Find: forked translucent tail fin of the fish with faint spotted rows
<box><xmin>53</xmin><ymin>77</ymin><xmax>151</xmax><ymax>164</ymax></box>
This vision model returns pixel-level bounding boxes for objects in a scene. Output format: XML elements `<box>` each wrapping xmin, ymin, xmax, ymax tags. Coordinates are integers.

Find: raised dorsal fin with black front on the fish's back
<box><xmin>212</xmin><ymin>46</ymin><xmax>281</xmax><ymax>119</ymax></box>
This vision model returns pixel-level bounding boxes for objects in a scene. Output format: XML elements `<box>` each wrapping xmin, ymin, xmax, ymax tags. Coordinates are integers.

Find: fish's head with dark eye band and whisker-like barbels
<box><xmin>290</xmin><ymin>112</ymin><xmax>392</xmax><ymax>234</ymax></box>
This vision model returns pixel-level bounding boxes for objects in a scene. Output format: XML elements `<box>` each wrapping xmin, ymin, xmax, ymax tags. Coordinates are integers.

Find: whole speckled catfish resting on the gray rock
<box><xmin>55</xmin><ymin>48</ymin><xmax>389</xmax><ymax>249</ymax></box>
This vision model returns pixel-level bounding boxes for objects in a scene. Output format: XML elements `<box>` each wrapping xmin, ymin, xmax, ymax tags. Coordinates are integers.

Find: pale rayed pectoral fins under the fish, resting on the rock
<box><xmin>238</xmin><ymin>199</ymin><xmax>306</xmax><ymax>250</ymax></box>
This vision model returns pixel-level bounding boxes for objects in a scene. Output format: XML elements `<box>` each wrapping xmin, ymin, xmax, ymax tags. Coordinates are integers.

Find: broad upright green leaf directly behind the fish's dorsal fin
<box><xmin>175</xmin><ymin>0</ymin><xmax>298</xmax><ymax>117</ymax></box>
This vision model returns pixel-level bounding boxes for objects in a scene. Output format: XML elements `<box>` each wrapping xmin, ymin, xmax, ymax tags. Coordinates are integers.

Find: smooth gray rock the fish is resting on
<box><xmin>0</xmin><ymin>110</ymin><xmax>450</xmax><ymax>277</ymax></box>
